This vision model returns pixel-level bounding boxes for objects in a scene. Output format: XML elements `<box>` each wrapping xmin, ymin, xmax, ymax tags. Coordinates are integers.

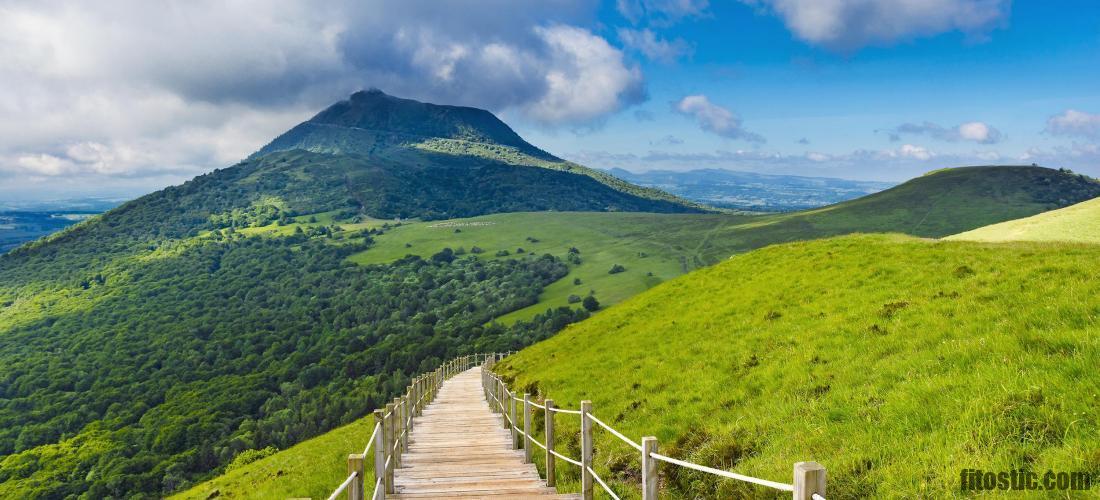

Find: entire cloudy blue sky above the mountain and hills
<box><xmin>0</xmin><ymin>0</ymin><xmax>1100</xmax><ymax>201</ymax></box>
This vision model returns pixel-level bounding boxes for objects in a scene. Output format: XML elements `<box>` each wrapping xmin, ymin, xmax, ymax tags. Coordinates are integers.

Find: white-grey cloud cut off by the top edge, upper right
<box><xmin>741</xmin><ymin>0</ymin><xmax>1011</xmax><ymax>51</ymax></box>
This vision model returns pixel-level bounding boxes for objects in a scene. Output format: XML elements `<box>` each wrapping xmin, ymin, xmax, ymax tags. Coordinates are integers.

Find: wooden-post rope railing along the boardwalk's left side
<box><xmin>329</xmin><ymin>354</ymin><xmax>504</xmax><ymax>500</ymax></box>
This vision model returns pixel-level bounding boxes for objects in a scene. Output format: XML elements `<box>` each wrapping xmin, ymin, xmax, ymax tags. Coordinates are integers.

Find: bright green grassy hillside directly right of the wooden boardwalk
<box><xmin>499</xmin><ymin>235</ymin><xmax>1100</xmax><ymax>498</ymax></box>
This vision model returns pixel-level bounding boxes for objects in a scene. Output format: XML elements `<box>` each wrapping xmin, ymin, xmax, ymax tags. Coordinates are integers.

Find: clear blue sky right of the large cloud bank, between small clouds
<box><xmin>519</xmin><ymin>1</ymin><xmax>1100</xmax><ymax>180</ymax></box>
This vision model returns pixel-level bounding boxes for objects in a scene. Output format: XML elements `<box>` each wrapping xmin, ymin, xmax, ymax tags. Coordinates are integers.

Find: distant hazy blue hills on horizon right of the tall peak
<box><xmin>608</xmin><ymin>168</ymin><xmax>894</xmax><ymax>212</ymax></box>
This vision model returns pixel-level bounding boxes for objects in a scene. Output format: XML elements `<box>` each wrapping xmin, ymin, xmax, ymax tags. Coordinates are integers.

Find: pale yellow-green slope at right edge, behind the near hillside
<box><xmin>945</xmin><ymin>193</ymin><xmax>1100</xmax><ymax>243</ymax></box>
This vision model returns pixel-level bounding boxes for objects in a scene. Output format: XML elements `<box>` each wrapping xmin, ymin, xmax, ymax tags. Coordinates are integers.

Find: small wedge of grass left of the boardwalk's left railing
<box><xmin>169</xmin><ymin>416</ymin><xmax>375</xmax><ymax>500</ymax></box>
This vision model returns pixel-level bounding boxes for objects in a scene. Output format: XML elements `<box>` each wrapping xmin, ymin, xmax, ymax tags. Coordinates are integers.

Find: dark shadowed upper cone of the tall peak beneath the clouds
<box><xmin>242</xmin><ymin>90</ymin><xmax>704</xmax><ymax>219</ymax></box>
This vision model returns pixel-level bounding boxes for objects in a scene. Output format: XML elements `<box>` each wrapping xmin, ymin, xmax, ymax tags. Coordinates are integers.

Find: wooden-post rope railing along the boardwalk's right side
<box><xmin>482</xmin><ymin>356</ymin><xmax>826</xmax><ymax>500</ymax></box>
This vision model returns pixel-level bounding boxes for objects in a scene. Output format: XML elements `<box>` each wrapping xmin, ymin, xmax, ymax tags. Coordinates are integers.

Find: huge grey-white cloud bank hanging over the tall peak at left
<box><xmin>0</xmin><ymin>0</ymin><xmax>645</xmax><ymax>195</ymax></box>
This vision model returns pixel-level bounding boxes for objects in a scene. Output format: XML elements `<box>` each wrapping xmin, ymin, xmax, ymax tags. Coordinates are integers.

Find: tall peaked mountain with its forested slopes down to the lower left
<box><xmin>0</xmin><ymin>92</ymin><xmax>704</xmax><ymax>498</ymax></box>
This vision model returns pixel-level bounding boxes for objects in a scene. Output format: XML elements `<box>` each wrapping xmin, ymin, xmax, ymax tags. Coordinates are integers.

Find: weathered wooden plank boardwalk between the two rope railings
<box><xmin>387</xmin><ymin>367</ymin><xmax>580</xmax><ymax>499</ymax></box>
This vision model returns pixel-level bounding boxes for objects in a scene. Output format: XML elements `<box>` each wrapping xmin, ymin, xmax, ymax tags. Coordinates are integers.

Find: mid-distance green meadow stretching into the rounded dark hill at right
<box><xmin>343</xmin><ymin>167</ymin><xmax>1100</xmax><ymax>323</ymax></box>
